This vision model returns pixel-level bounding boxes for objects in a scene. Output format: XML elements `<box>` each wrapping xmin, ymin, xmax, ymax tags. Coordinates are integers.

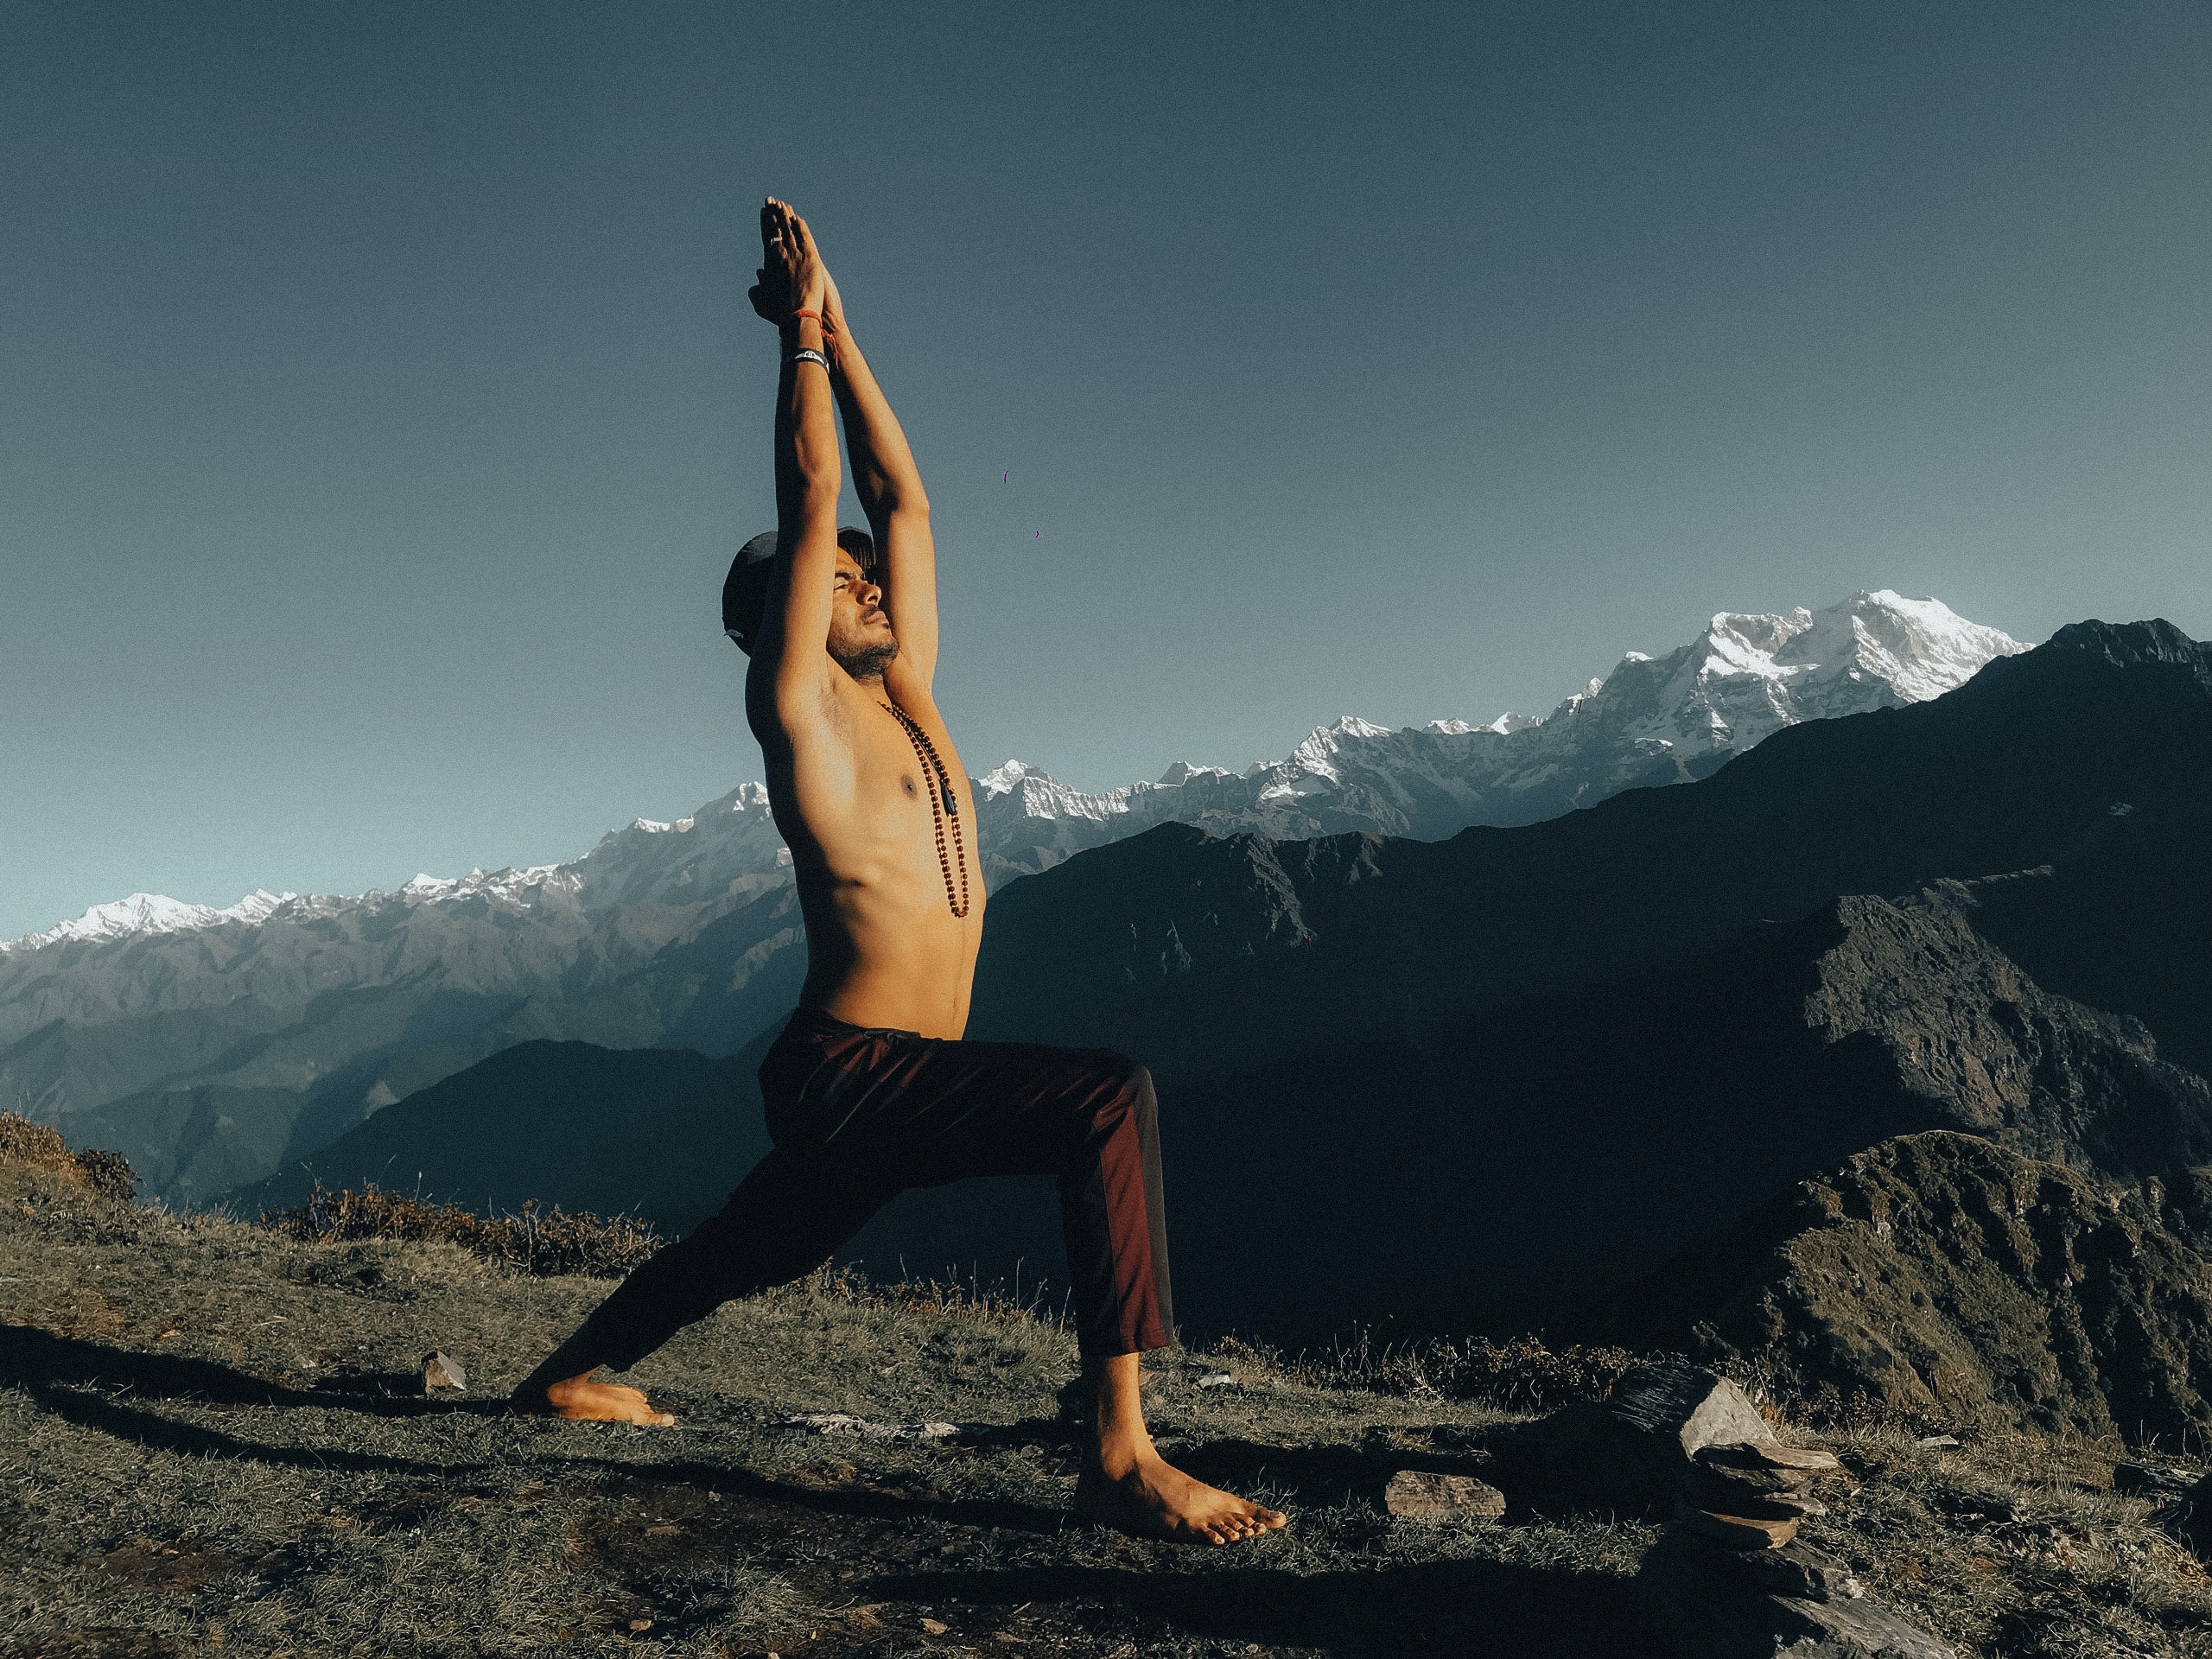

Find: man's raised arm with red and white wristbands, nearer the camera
<box><xmin>752</xmin><ymin>197</ymin><xmax>842</xmax><ymax>715</ymax></box>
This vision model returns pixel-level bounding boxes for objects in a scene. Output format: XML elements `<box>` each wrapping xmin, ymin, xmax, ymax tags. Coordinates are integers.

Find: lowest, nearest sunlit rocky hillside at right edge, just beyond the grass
<box><xmin>1615</xmin><ymin>1133</ymin><xmax>2212</xmax><ymax>1440</ymax></box>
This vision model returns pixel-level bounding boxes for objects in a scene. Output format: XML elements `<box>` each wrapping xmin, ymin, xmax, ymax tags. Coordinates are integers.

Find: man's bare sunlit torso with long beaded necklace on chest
<box><xmin>752</xmin><ymin>675</ymin><xmax>984</xmax><ymax>1038</ymax></box>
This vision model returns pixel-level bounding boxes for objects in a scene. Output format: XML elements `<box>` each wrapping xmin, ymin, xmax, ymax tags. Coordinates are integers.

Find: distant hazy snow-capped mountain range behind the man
<box><xmin>0</xmin><ymin>591</ymin><xmax>2024</xmax><ymax>1201</ymax></box>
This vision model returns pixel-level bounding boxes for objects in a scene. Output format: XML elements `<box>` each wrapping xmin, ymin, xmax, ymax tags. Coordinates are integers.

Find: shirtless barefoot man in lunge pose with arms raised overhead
<box><xmin>513</xmin><ymin>199</ymin><xmax>1283</xmax><ymax>1544</ymax></box>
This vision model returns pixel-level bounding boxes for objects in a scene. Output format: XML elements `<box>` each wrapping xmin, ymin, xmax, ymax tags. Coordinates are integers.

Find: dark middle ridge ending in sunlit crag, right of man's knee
<box><xmin>1161</xmin><ymin>893</ymin><xmax>2212</xmax><ymax>1332</ymax></box>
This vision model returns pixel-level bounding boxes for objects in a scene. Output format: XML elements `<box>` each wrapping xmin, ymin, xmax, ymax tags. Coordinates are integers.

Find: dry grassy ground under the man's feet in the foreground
<box><xmin>0</xmin><ymin>1168</ymin><xmax>2212</xmax><ymax>1659</ymax></box>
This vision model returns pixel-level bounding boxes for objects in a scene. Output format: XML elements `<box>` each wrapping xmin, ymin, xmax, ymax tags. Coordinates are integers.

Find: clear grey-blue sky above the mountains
<box><xmin>0</xmin><ymin>0</ymin><xmax>2212</xmax><ymax>936</ymax></box>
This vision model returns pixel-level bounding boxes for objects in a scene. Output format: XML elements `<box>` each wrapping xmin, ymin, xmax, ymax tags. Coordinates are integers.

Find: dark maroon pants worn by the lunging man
<box><xmin>584</xmin><ymin>1008</ymin><xmax>1174</xmax><ymax>1371</ymax></box>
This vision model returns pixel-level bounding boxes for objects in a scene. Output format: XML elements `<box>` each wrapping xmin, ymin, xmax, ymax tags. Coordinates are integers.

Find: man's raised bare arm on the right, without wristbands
<box><xmin>825</xmin><ymin>281</ymin><xmax>938</xmax><ymax>699</ymax></box>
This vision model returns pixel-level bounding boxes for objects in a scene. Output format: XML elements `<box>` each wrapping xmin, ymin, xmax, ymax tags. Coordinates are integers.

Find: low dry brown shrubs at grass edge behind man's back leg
<box><xmin>257</xmin><ymin>1181</ymin><xmax>664</xmax><ymax>1279</ymax></box>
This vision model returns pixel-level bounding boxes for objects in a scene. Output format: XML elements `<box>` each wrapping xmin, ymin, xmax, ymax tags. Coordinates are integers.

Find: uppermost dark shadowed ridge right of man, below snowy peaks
<box><xmin>971</xmin><ymin>624</ymin><xmax>2212</xmax><ymax>1068</ymax></box>
